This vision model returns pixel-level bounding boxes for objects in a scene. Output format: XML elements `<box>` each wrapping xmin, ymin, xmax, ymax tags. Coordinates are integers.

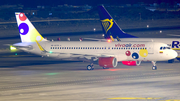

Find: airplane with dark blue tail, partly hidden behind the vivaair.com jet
<box><xmin>97</xmin><ymin>5</ymin><xmax>180</xmax><ymax>63</ymax></box>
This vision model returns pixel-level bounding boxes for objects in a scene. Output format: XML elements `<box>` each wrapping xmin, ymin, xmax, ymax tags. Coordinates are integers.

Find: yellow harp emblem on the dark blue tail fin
<box><xmin>101</xmin><ymin>19</ymin><xmax>114</xmax><ymax>33</ymax></box>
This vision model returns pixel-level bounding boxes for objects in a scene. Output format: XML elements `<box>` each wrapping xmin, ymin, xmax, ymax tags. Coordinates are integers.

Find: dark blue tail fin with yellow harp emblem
<box><xmin>98</xmin><ymin>6</ymin><xmax>137</xmax><ymax>38</ymax></box>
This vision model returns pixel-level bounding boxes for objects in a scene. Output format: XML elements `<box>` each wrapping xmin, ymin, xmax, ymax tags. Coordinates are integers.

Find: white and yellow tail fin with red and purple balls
<box><xmin>15</xmin><ymin>12</ymin><xmax>47</xmax><ymax>42</ymax></box>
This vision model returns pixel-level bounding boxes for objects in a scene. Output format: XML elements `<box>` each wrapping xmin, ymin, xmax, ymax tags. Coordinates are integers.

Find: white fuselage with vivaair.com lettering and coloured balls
<box><xmin>14</xmin><ymin>41</ymin><xmax>177</xmax><ymax>61</ymax></box>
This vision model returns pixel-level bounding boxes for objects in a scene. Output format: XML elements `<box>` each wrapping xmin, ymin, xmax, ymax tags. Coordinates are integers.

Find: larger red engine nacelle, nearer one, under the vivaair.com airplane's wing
<box><xmin>98</xmin><ymin>57</ymin><xmax>118</xmax><ymax>68</ymax></box>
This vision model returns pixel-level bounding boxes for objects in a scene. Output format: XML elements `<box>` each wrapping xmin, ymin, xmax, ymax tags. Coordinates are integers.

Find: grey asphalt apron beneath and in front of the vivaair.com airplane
<box><xmin>0</xmin><ymin>53</ymin><xmax>180</xmax><ymax>101</ymax></box>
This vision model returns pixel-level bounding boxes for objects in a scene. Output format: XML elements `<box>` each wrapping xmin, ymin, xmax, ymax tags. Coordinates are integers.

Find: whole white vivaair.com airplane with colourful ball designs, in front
<box><xmin>12</xmin><ymin>12</ymin><xmax>177</xmax><ymax>70</ymax></box>
